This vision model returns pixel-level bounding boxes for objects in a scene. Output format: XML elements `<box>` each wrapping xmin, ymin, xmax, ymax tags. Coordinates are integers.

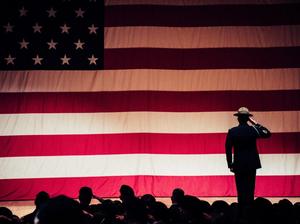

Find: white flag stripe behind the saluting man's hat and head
<box><xmin>0</xmin><ymin>111</ymin><xmax>300</xmax><ymax>136</ymax></box>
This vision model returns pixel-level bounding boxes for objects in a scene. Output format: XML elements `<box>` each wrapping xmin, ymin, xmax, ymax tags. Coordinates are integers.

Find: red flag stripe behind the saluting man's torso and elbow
<box><xmin>0</xmin><ymin>132</ymin><xmax>300</xmax><ymax>157</ymax></box>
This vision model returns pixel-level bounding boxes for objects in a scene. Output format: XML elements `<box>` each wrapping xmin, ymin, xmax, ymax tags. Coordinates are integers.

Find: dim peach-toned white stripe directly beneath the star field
<box><xmin>0</xmin><ymin>68</ymin><xmax>300</xmax><ymax>92</ymax></box>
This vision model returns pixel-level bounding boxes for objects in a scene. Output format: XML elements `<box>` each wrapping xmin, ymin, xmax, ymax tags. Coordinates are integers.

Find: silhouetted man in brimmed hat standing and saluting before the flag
<box><xmin>225</xmin><ymin>107</ymin><xmax>271</xmax><ymax>206</ymax></box>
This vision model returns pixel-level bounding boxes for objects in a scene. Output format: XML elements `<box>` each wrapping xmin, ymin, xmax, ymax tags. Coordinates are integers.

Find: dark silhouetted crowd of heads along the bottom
<box><xmin>0</xmin><ymin>185</ymin><xmax>300</xmax><ymax>224</ymax></box>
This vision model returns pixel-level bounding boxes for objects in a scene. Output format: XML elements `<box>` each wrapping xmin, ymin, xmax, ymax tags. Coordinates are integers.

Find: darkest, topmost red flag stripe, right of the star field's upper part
<box><xmin>104</xmin><ymin>4</ymin><xmax>300</xmax><ymax>27</ymax></box>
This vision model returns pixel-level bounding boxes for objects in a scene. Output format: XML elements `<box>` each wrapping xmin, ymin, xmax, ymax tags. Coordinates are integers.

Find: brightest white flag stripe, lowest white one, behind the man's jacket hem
<box><xmin>0</xmin><ymin>154</ymin><xmax>300</xmax><ymax>179</ymax></box>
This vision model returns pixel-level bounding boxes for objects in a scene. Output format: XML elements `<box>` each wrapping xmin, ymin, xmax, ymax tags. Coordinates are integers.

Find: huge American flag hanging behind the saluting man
<box><xmin>0</xmin><ymin>0</ymin><xmax>300</xmax><ymax>200</ymax></box>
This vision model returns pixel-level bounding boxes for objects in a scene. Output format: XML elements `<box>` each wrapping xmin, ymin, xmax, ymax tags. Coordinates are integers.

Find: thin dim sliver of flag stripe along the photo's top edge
<box><xmin>105</xmin><ymin>0</ymin><xmax>298</xmax><ymax>5</ymax></box>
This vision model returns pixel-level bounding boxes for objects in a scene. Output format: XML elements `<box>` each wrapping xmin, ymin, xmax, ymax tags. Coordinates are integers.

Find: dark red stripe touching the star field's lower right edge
<box><xmin>104</xmin><ymin>47</ymin><xmax>300</xmax><ymax>70</ymax></box>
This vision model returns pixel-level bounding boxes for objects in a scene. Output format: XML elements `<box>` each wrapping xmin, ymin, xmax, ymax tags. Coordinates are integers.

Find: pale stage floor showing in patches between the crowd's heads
<box><xmin>0</xmin><ymin>197</ymin><xmax>300</xmax><ymax>217</ymax></box>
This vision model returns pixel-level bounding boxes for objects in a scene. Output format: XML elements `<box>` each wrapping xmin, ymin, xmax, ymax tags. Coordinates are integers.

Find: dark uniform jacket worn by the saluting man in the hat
<box><xmin>225</xmin><ymin>124</ymin><xmax>271</xmax><ymax>171</ymax></box>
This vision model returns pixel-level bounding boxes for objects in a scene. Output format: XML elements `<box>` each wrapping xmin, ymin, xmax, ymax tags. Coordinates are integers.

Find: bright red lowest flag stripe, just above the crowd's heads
<box><xmin>0</xmin><ymin>176</ymin><xmax>300</xmax><ymax>200</ymax></box>
